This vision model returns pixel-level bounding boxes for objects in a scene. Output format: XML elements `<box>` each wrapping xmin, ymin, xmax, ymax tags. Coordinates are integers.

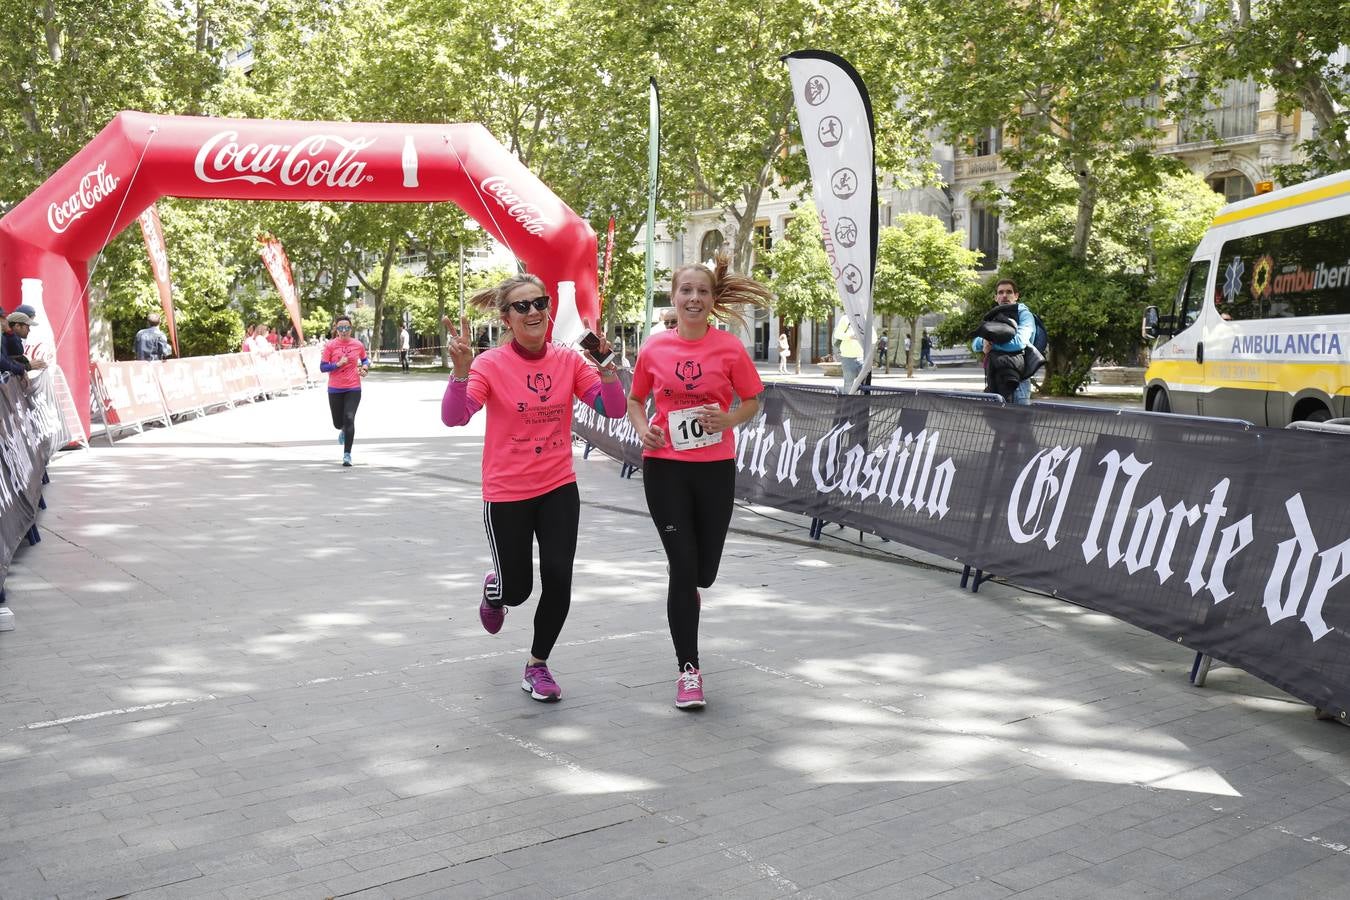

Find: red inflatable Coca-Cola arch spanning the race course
<box><xmin>0</xmin><ymin>112</ymin><xmax>599</xmax><ymax>429</ymax></box>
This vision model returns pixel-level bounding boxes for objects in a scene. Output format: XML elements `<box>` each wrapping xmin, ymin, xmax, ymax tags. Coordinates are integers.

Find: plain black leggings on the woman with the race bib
<box><xmin>643</xmin><ymin>457</ymin><xmax>736</xmax><ymax>669</ymax></box>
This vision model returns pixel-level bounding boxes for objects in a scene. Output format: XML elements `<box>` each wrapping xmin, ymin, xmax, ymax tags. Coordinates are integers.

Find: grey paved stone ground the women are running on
<box><xmin>0</xmin><ymin>375</ymin><xmax>1350</xmax><ymax>900</ymax></box>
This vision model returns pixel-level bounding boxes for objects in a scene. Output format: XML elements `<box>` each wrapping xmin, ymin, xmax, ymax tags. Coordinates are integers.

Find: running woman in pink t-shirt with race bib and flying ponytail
<box><xmin>628</xmin><ymin>255</ymin><xmax>772</xmax><ymax>710</ymax></box>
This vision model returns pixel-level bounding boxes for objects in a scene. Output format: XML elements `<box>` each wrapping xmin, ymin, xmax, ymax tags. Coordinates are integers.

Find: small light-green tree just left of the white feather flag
<box><xmin>757</xmin><ymin>200</ymin><xmax>838</xmax><ymax>374</ymax></box>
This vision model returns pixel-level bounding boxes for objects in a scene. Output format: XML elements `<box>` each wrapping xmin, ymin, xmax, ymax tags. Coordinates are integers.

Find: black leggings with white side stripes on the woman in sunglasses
<box><xmin>483</xmin><ymin>482</ymin><xmax>582</xmax><ymax>660</ymax></box>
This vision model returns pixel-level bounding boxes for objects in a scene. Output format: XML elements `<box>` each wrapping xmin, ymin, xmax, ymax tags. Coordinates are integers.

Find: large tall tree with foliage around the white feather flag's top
<box><xmin>621</xmin><ymin>0</ymin><xmax>926</xmax><ymax>273</ymax></box>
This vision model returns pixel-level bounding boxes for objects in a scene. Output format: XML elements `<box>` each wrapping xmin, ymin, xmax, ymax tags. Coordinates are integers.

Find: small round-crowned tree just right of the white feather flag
<box><xmin>872</xmin><ymin>213</ymin><xmax>980</xmax><ymax>378</ymax></box>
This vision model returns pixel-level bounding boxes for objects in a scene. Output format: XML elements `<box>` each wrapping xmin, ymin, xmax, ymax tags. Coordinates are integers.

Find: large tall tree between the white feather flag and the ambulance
<box><xmin>912</xmin><ymin>0</ymin><xmax>1196</xmax><ymax>260</ymax></box>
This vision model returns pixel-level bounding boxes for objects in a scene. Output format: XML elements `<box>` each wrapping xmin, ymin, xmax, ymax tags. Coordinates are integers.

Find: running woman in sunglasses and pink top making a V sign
<box><xmin>440</xmin><ymin>274</ymin><xmax>625</xmax><ymax>702</ymax></box>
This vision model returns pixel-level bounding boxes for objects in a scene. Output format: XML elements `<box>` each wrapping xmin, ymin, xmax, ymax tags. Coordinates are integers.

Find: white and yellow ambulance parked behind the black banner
<box><xmin>1143</xmin><ymin>170</ymin><xmax>1350</xmax><ymax>428</ymax></box>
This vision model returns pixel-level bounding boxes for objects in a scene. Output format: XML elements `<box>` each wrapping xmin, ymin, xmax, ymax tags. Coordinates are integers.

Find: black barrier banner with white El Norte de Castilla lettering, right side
<box><xmin>576</xmin><ymin>385</ymin><xmax>1350</xmax><ymax>714</ymax></box>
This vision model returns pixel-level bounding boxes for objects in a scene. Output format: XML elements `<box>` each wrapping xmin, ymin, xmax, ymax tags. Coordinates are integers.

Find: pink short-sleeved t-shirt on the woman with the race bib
<box><xmin>630</xmin><ymin>328</ymin><xmax>764</xmax><ymax>463</ymax></box>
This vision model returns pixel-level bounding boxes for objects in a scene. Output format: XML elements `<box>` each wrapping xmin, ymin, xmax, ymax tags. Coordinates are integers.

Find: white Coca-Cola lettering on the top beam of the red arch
<box><xmin>192</xmin><ymin>131</ymin><xmax>375</xmax><ymax>188</ymax></box>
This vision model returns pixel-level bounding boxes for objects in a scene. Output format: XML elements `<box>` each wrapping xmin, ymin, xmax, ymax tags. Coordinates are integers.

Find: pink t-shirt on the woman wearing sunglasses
<box><xmin>467</xmin><ymin>344</ymin><xmax>599</xmax><ymax>503</ymax></box>
